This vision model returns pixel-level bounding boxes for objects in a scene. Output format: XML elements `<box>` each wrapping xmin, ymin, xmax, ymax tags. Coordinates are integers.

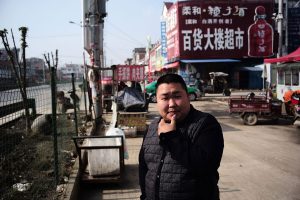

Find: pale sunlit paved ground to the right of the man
<box><xmin>197</xmin><ymin>102</ymin><xmax>300</xmax><ymax>200</ymax></box>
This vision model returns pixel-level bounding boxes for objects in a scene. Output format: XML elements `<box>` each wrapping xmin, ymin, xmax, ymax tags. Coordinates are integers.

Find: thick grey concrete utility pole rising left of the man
<box><xmin>82</xmin><ymin>0</ymin><xmax>106</xmax><ymax>128</ymax></box>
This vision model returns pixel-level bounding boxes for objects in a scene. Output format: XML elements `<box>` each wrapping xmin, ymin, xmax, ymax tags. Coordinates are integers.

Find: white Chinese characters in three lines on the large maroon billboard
<box><xmin>181</xmin><ymin>5</ymin><xmax>248</xmax><ymax>55</ymax></box>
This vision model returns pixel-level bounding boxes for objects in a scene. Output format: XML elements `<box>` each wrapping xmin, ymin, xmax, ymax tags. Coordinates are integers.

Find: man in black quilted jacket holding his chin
<box><xmin>139</xmin><ymin>74</ymin><xmax>224</xmax><ymax>200</ymax></box>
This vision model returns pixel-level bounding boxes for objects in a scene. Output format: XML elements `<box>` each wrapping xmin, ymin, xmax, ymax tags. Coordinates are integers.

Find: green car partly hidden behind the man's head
<box><xmin>145</xmin><ymin>81</ymin><xmax>201</xmax><ymax>103</ymax></box>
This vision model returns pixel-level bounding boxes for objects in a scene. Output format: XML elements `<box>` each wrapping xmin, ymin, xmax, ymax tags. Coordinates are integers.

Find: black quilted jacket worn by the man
<box><xmin>140</xmin><ymin>107</ymin><xmax>224</xmax><ymax>200</ymax></box>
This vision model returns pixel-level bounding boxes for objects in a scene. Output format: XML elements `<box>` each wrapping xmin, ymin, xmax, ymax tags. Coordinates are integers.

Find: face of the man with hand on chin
<box><xmin>156</xmin><ymin>83</ymin><xmax>190</xmax><ymax>122</ymax></box>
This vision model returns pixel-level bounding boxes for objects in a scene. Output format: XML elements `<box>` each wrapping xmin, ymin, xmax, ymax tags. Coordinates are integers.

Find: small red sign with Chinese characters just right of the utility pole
<box><xmin>117</xmin><ymin>65</ymin><xmax>145</xmax><ymax>81</ymax></box>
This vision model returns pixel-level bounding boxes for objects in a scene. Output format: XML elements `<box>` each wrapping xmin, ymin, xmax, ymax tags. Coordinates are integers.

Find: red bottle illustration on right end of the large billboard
<box><xmin>248</xmin><ymin>6</ymin><xmax>274</xmax><ymax>57</ymax></box>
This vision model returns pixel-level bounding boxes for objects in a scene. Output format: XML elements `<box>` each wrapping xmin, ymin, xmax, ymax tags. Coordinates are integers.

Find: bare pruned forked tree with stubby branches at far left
<box><xmin>0</xmin><ymin>27</ymin><xmax>31</xmax><ymax>133</ymax></box>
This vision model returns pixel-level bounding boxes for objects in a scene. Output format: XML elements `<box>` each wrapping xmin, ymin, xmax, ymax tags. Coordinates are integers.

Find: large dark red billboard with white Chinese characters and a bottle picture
<box><xmin>167</xmin><ymin>0</ymin><xmax>275</xmax><ymax>61</ymax></box>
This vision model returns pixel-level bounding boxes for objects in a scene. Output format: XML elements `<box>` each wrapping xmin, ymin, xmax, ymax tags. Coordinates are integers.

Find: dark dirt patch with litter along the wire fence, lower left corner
<box><xmin>0</xmin><ymin>114</ymin><xmax>88</xmax><ymax>200</ymax></box>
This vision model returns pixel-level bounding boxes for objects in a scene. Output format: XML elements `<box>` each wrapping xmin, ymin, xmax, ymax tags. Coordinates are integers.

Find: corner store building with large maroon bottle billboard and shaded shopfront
<box><xmin>149</xmin><ymin>0</ymin><xmax>277</xmax><ymax>89</ymax></box>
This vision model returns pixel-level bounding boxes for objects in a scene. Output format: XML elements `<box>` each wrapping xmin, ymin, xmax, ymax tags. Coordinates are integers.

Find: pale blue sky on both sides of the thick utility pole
<box><xmin>0</xmin><ymin>0</ymin><xmax>172</xmax><ymax>66</ymax></box>
